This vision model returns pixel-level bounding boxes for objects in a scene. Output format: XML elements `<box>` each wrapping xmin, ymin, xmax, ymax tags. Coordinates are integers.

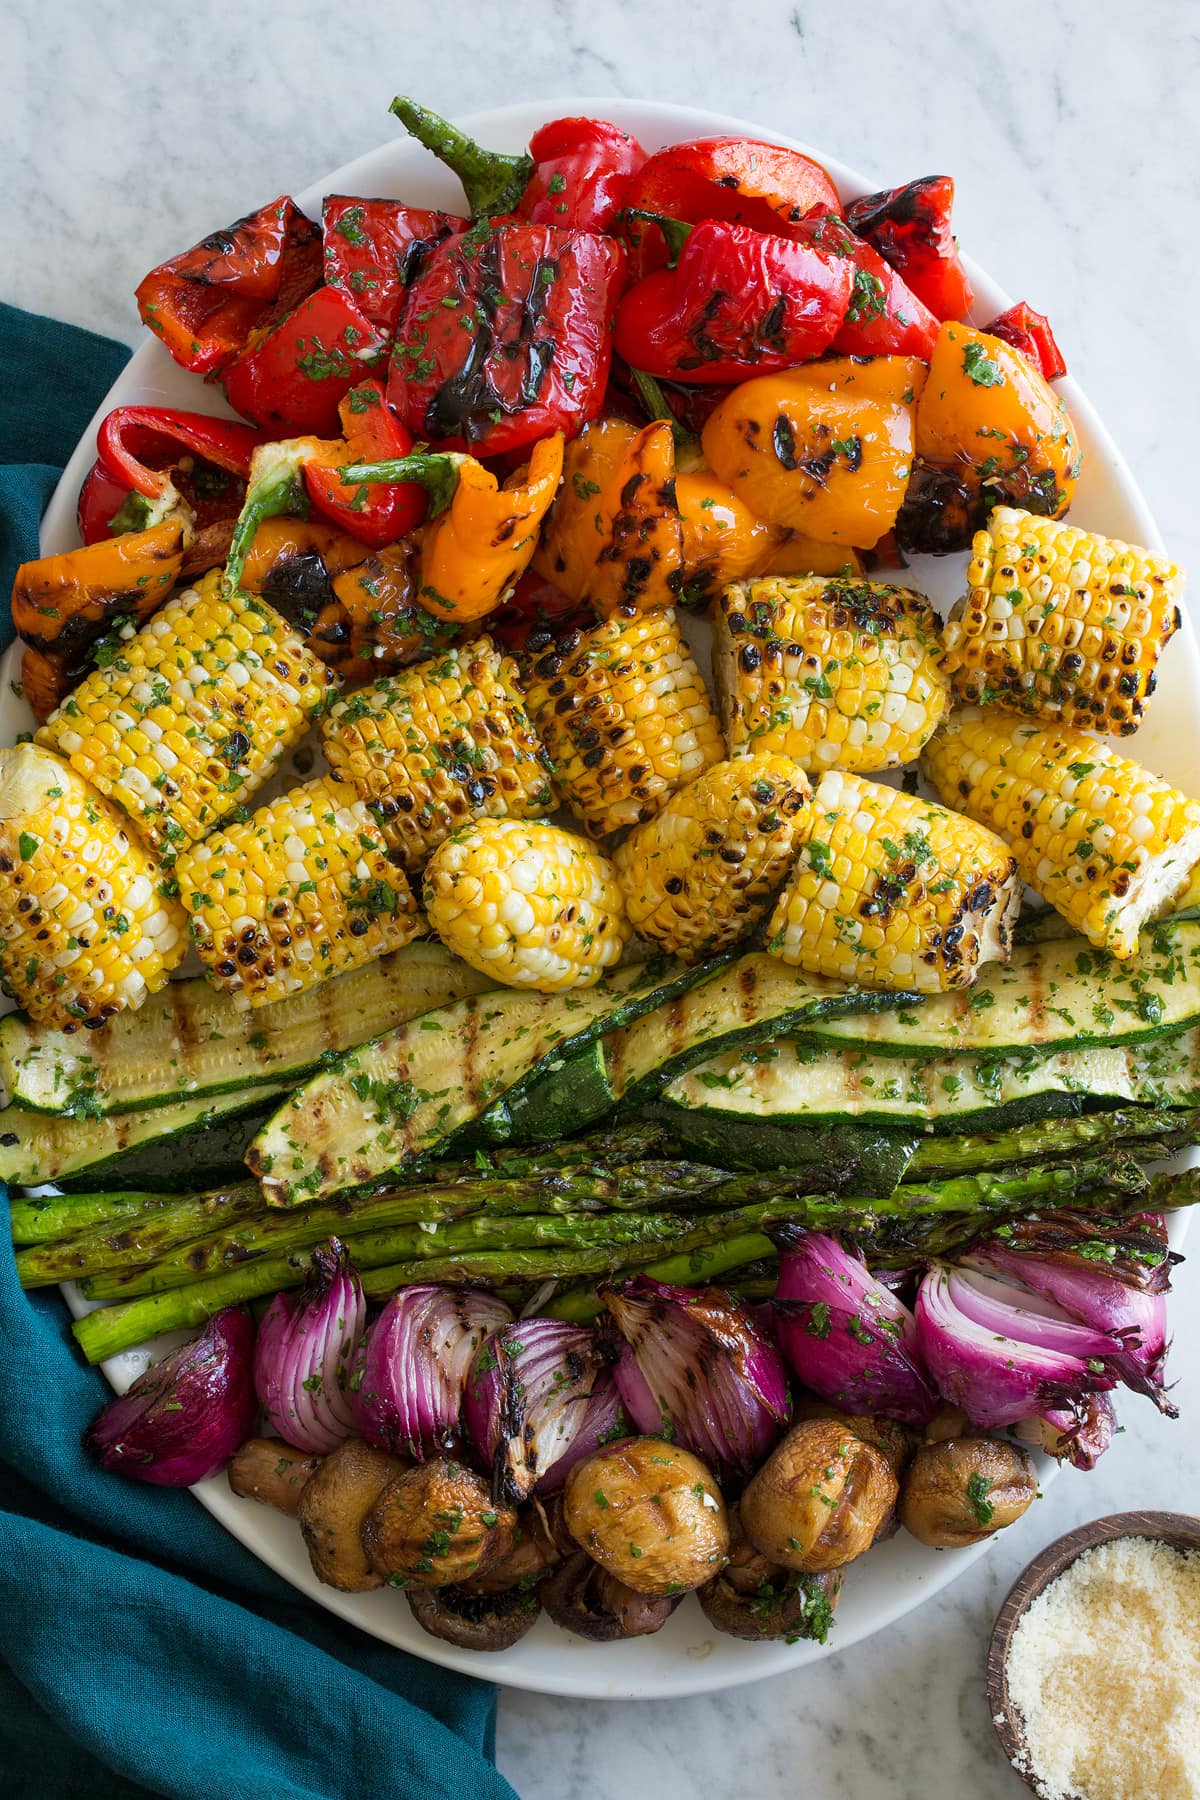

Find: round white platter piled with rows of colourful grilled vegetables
<box><xmin>0</xmin><ymin>97</ymin><xmax>1200</xmax><ymax>1692</ymax></box>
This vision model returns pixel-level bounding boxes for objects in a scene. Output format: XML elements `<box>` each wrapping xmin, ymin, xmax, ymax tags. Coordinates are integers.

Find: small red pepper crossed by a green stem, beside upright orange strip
<box><xmin>304</xmin><ymin>382</ymin><xmax>430</xmax><ymax>551</ymax></box>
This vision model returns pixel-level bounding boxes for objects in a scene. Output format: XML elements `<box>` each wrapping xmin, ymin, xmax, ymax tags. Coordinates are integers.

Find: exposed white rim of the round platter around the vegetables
<box><xmin>28</xmin><ymin>94</ymin><xmax>1200</xmax><ymax>1699</ymax></box>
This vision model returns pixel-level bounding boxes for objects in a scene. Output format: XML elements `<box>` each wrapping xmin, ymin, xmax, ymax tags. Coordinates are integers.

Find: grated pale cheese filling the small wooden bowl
<box><xmin>1007</xmin><ymin>1537</ymin><xmax>1200</xmax><ymax>1800</ymax></box>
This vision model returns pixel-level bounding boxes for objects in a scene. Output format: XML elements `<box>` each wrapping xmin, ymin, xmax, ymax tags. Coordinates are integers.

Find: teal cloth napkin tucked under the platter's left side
<box><xmin>0</xmin><ymin>304</ymin><xmax>515</xmax><ymax>1800</ymax></box>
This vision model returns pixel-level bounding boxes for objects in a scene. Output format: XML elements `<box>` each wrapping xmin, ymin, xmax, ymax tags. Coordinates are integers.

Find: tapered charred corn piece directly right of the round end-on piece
<box><xmin>613</xmin><ymin>756</ymin><xmax>811</xmax><ymax>959</ymax></box>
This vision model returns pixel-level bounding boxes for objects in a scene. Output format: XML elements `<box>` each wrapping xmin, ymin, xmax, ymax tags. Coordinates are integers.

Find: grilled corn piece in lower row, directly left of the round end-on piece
<box><xmin>176</xmin><ymin>776</ymin><xmax>425</xmax><ymax>1008</ymax></box>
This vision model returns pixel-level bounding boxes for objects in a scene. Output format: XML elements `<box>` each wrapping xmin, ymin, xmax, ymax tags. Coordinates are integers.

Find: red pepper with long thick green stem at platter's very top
<box><xmin>392</xmin><ymin>94</ymin><xmax>646</xmax><ymax>232</ymax></box>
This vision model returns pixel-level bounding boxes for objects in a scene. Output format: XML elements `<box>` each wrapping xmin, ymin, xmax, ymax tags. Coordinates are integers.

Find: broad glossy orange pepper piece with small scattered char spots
<box><xmin>702</xmin><ymin>356</ymin><xmax>927</xmax><ymax>549</ymax></box>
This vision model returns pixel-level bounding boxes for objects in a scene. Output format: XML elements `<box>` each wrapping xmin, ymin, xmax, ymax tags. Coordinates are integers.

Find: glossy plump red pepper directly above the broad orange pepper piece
<box><xmin>615</xmin><ymin>220</ymin><xmax>855</xmax><ymax>385</ymax></box>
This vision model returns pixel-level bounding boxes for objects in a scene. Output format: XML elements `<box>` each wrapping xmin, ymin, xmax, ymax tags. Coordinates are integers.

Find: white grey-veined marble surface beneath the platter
<box><xmin>0</xmin><ymin>0</ymin><xmax>1200</xmax><ymax>1800</ymax></box>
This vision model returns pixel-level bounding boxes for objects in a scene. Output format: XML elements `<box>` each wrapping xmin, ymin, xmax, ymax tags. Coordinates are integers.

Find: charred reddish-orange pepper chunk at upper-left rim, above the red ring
<box><xmin>137</xmin><ymin>194</ymin><xmax>320</xmax><ymax>374</ymax></box>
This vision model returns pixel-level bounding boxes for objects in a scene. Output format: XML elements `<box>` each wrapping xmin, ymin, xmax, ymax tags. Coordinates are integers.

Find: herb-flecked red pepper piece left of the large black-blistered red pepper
<box><xmin>221</xmin><ymin>286</ymin><xmax>387</xmax><ymax>437</ymax></box>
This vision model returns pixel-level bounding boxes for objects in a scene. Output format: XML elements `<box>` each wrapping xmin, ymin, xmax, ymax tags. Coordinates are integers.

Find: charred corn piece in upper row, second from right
<box><xmin>712</xmin><ymin>578</ymin><xmax>948</xmax><ymax>774</ymax></box>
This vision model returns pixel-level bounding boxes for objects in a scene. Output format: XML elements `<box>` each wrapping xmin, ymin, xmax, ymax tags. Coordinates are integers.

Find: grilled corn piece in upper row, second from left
<box><xmin>322</xmin><ymin>637</ymin><xmax>554</xmax><ymax>869</ymax></box>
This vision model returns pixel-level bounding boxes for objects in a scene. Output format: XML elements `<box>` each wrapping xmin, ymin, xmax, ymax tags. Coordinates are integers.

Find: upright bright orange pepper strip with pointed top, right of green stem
<box><xmin>419</xmin><ymin>432</ymin><xmax>563</xmax><ymax>625</ymax></box>
